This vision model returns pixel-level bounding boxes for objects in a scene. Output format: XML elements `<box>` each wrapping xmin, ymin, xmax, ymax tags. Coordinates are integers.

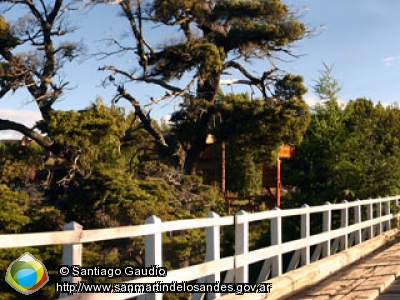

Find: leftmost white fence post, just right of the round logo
<box><xmin>60</xmin><ymin>221</ymin><xmax>83</xmax><ymax>298</ymax></box>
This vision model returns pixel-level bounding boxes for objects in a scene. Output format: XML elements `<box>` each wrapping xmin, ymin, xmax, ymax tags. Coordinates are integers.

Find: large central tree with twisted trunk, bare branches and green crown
<box><xmin>92</xmin><ymin>0</ymin><xmax>307</xmax><ymax>174</ymax></box>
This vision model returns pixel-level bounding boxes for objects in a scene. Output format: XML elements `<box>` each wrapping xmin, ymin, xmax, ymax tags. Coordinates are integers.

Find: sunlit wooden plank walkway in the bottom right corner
<box><xmin>282</xmin><ymin>237</ymin><xmax>400</xmax><ymax>300</ymax></box>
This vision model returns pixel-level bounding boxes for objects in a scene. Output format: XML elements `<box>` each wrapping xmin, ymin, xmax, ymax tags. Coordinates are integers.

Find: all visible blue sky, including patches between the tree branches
<box><xmin>0</xmin><ymin>0</ymin><xmax>400</xmax><ymax>137</ymax></box>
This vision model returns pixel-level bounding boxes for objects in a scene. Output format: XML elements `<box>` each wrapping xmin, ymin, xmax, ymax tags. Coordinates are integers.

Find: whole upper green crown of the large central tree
<box><xmin>150</xmin><ymin>0</ymin><xmax>305</xmax><ymax>80</ymax></box>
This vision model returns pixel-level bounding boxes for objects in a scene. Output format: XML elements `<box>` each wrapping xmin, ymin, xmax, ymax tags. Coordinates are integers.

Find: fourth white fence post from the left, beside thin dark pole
<box><xmin>235</xmin><ymin>210</ymin><xmax>249</xmax><ymax>283</ymax></box>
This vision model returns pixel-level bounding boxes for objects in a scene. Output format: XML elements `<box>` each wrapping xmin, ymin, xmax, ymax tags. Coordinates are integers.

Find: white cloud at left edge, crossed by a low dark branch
<box><xmin>0</xmin><ymin>109</ymin><xmax>42</xmax><ymax>139</ymax></box>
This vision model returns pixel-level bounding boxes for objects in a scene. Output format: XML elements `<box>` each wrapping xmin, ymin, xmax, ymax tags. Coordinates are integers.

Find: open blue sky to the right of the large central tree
<box><xmin>286</xmin><ymin>0</ymin><xmax>400</xmax><ymax>104</ymax></box>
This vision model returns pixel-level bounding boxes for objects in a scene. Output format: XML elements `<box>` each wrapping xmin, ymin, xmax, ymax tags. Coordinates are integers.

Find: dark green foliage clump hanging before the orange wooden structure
<box><xmin>213</xmin><ymin>91</ymin><xmax>309</xmax><ymax>194</ymax></box>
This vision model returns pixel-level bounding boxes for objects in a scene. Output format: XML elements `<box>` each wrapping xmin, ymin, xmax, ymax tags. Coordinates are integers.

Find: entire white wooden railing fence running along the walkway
<box><xmin>0</xmin><ymin>196</ymin><xmax>400</xmax><ymax>300</ymax></box>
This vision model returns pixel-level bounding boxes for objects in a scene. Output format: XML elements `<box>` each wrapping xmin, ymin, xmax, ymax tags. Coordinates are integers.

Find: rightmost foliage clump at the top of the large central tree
<box><xmin>212</xmin><ymin>0</ymin><xmax>305</xmax><ymax>55</ymax></box>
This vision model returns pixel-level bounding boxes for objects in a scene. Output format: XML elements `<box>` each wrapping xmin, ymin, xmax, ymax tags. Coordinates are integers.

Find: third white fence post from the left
<box><xmin>206</xmin><ymin>212</ymin><xmax>221</xmax><ymax>299</ymax></box>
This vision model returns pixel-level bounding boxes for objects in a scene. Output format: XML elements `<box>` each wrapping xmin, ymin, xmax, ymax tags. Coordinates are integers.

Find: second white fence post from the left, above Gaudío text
<box><xmin>144</xmin><ymin>215</ymin><xmax>163</xmax><ymax>300</ymax></box>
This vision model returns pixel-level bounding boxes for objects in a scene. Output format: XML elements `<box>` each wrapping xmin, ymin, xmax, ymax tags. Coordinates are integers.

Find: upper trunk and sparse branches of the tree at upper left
<box><xmin>0</xmin><ymin>0</ymin><xmax>80</xmax><ymax>118</ymax></box>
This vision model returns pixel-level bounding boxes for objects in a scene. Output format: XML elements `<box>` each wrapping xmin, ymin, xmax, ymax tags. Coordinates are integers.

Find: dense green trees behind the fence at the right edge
<box><xmin>290</xmin><ymin>99</ymin><xmax>400</xmax><ymax>204</ymax></box>
